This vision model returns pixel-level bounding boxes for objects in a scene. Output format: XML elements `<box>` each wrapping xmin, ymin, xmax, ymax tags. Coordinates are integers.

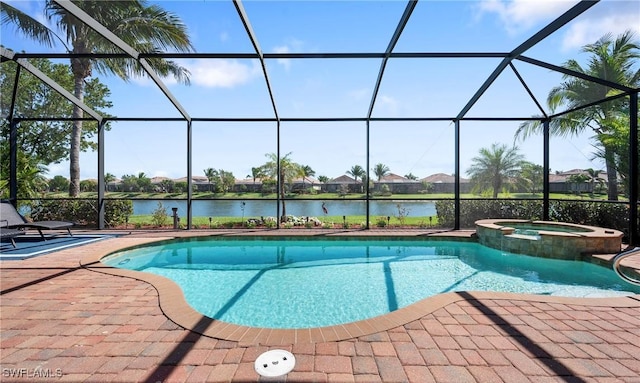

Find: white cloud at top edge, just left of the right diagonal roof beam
<box><xmin>477</xmin><ymin>0</ymin><xmax>576</xmax><ymax>35</ymax></box>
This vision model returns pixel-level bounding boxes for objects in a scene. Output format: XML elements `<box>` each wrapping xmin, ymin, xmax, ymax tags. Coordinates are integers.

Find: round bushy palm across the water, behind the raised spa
<box><xmin>467</xmin><ymin>143</ymin><xmax>524</xmax><ymax>198</ymax></box>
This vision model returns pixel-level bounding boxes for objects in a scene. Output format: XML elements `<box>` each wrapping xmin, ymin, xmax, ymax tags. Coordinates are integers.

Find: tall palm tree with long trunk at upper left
<box><xmin>0</xmin><ymin>0</ymin><xmax>194</xmax><ymax>197</ymax></box>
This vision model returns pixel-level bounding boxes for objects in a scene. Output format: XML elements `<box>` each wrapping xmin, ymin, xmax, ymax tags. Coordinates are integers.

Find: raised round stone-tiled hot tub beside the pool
<box><xmin>475</xmin><ymin>219</ymin><xmax>623</xmax><ymax>260</ymax></box>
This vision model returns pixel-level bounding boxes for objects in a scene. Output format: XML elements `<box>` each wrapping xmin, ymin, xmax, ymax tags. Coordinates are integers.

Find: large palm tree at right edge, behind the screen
<box><xmin>516</xmin><ymin>31</ymin><xmax>640</xmax><ymax>201</ymax></box>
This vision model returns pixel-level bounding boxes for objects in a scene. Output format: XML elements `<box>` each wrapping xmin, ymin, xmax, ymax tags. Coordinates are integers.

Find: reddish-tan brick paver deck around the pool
<box><xmin>0</xmin><ymin>232</ymin><xmax>640</xmax><ymax>383</ymax></box>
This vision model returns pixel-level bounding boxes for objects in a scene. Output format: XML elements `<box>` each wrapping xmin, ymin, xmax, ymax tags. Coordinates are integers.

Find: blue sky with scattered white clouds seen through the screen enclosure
<box><xmin>0</xmin><ymin>0</ymin><xmax>640</xmax><ymax>182</ymax></box>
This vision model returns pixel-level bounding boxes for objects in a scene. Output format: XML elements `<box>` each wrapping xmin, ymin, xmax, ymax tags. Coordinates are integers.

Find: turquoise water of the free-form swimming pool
<box><xmin>102</xmin><ymin>237</ymin><xmax>640</xmax><ymax>328</ymax></box>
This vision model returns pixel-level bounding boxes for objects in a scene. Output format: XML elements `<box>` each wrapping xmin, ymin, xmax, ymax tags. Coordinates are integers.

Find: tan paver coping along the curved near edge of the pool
<box><xmin>80</xmin><ymin>236</ymin><xmax>640</xmax><ymax>346</ymax></box>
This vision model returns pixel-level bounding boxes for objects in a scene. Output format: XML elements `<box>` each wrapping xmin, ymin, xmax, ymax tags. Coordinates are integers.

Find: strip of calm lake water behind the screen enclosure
<box><xmin>133</xmin><ymin>200</ymin><xmax>437</xmax><ymax>218</ymax></box>
